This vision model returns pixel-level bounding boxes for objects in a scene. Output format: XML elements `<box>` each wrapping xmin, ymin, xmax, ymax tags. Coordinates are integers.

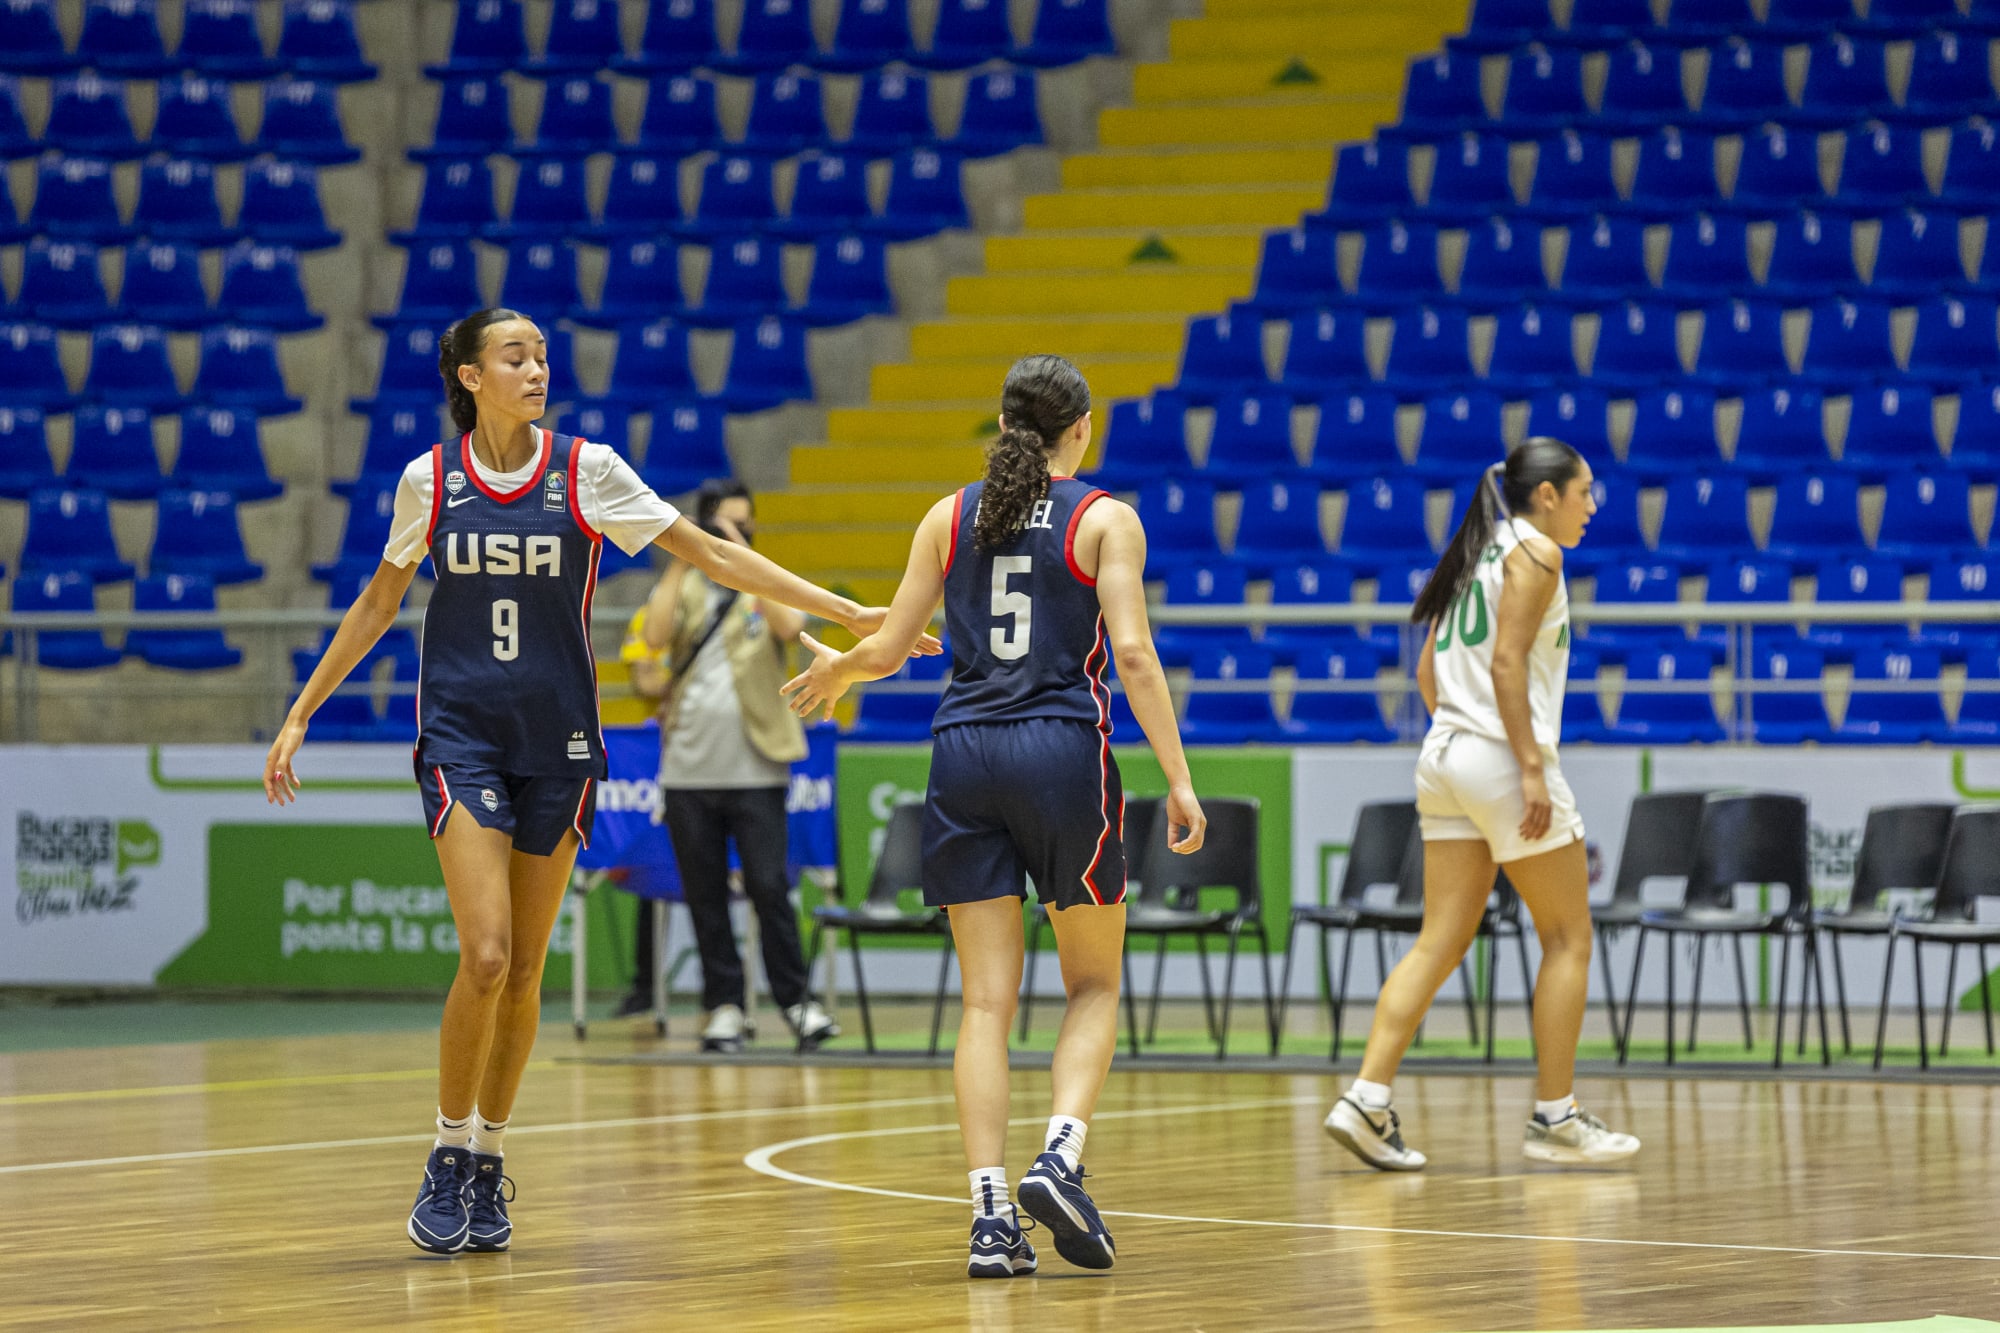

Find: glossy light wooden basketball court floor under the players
<box><xmin>0</xmin><ymin>1012</ymin><xmax>2000</xmax><ymax>1333</ymax></box>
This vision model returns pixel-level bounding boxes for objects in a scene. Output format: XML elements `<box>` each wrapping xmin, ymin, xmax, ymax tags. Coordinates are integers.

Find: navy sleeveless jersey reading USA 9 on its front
<box><xmin>416</xmin><ymin>430</ymin><xmax>606</xmax><ymax>779</ymax></box>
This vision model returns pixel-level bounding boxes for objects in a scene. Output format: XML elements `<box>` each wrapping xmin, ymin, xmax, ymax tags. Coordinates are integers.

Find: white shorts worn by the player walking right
<box><xmin>1416</xmin><ymin>731</ymin><xmax>1584</xmax><ymax>865</ymax></box>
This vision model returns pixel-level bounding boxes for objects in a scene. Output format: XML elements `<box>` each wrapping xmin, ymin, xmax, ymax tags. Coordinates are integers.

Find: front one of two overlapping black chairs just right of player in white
<box><xmin>1618</xmin><ymin>793</ymin><xmax>1832</xmax><ymax>1069</ymax></box>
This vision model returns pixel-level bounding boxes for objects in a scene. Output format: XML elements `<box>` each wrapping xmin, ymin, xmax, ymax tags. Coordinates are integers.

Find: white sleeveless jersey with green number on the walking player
<box><xmin>1430</xmin><ymin>518</ymin><xmax>1570</xmax><ymax>751</ymax></box>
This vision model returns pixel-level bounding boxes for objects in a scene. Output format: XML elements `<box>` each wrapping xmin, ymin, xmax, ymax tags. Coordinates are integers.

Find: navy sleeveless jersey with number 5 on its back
<box><xmin>930</xmin><ymin>476</ymin><xmax>1110</xmax><ymax>733</ymax></box>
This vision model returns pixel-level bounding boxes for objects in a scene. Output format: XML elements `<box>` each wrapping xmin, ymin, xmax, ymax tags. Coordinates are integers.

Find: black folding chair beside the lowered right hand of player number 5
<box><xmin>1124</xmin><ymin>797</ymin><xmax>1276</xmax><ymax>1059</ymax></box>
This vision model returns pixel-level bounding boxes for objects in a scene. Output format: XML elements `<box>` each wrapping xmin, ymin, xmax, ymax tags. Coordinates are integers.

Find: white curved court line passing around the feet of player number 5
<box><xmin>742</xmin><ymin>1097</ymin><xmax>2000</xmax><ymax>1263</ymax></box>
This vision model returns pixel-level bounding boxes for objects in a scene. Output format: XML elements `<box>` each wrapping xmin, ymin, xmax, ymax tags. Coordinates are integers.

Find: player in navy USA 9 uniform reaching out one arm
<box><xmin>264</xmin><ymin>308</ymin><xmax>936</xmax><ymax>1253</ymax></box>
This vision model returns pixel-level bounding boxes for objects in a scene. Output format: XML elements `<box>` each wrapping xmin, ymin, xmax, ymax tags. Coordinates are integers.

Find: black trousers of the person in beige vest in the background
<box><xmin>660</xmin><ymin>787</ymin><xmax>808</xmax><ymax>1009</ymax></box>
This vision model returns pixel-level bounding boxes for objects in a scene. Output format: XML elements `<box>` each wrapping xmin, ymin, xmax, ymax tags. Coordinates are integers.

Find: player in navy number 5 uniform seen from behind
<box><xmin>784</xmin><ymin>356</ymin><xmax>1208</xmax><ymax>1277</ymax></box>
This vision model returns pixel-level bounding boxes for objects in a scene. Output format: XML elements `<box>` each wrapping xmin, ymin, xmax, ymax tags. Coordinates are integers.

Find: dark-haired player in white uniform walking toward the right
<box><xmin>1326</xmin><ymin>438</ymin><xmax>1638</xmax><ymax>1171</ymax></box>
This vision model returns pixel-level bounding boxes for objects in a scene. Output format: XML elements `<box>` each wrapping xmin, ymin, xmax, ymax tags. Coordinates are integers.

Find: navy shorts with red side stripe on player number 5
<box><xmin>924</xmin><ymin>719</ymin><xmax>1126</xmax><ymax>911</ymax></box>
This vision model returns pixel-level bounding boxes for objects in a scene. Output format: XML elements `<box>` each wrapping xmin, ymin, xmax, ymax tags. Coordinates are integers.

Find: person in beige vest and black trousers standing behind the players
<box><xmin>636</xmin><ymin>480</ymin><xmax>840</xmax><ymax>1053</ymax></box>
